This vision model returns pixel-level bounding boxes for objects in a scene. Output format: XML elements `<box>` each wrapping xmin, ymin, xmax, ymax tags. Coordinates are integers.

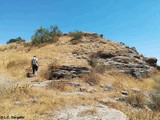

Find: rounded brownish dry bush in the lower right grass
<box><xmin>126</xmin><ymin>93</ymin><xmax>145</xmax><ymax>108</ymax></box>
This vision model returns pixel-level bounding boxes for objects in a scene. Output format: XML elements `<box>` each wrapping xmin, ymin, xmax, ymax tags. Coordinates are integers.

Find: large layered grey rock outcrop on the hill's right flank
<box><xmin>96</xmin><ymin>46</ymin><xmax>157</xmax><ymax>78</ymax></box>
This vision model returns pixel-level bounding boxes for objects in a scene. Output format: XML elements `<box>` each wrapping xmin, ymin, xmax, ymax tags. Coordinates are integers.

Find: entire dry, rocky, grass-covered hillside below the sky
<box><xmin>0</xmin><ymin>32</ymin><xmax>160</xmax><ymax>120</ymax></box>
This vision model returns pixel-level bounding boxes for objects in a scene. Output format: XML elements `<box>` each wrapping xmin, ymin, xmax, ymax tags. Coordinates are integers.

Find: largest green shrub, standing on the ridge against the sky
<box><xmin>32</xmin><ymin>26</ymin><xmax>62</xmax><ymax>46</ymax></box>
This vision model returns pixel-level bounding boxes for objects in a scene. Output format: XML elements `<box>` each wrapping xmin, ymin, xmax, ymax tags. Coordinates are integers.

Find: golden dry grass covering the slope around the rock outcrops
<box><xmin>0</xmin><ymin>33</ymin><xmax>160</xmax><ymax>120</ymax></box>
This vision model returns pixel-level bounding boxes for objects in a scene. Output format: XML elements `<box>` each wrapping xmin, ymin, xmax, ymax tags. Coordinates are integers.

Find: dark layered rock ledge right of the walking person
<box><xmin>50</xmin><ymin>66</ymin><xmax>91</xmax><ymax>79</ymax></box>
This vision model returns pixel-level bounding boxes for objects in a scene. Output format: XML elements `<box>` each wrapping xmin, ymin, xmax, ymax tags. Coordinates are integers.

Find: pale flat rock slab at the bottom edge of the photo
<box><xmin>52</xmin><ymin>105</ymin><xmax>128</xmax><ymax>120</ymax></box>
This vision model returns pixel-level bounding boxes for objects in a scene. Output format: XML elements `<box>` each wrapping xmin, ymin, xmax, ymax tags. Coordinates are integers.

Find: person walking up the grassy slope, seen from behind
<box><xmin>31</xmin><ymin>56</ymin><xmax>38</xmax><ymax>75</ymax></box>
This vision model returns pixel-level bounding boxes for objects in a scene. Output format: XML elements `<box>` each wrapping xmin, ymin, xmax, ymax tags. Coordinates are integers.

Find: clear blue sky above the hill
<box><xmin>0</xmin><ymin>0</ymin><xmax>160</xmax><ymax>63</ymax></box>
